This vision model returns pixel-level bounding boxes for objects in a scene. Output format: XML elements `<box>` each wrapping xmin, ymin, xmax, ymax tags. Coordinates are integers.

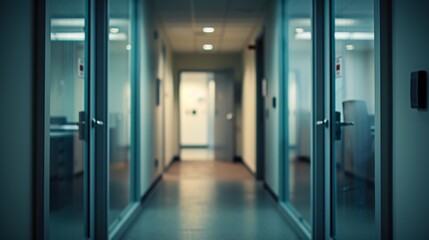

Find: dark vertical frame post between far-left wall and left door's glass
<box><xmin>32</xmin><ymin>0</ymin><xmax>50</xmax><ymax>239</ymax></box>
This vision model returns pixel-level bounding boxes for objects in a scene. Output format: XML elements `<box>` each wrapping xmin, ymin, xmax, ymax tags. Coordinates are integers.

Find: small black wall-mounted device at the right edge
<box><xmin>410</xmin><ymin>71</ymin><xmax>428</xmax><ymax>109</ymax></box>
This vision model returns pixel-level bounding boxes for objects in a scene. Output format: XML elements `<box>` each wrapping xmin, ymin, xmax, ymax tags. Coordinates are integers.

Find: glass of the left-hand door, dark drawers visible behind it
<box><xmin>47</xmin><ymin>0</ymin><xmax>86</xmax><ymax>239</ymax></box>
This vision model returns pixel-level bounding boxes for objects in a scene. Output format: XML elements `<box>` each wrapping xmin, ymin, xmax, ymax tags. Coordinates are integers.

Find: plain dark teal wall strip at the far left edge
<box><xmin>0</xmin><ymin>0</ymin><xmax>34</xmax><ymax>239</ymax></box>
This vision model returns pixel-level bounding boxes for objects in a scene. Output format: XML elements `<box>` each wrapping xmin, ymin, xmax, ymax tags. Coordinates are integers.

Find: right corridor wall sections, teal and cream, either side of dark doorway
<box><xmin>241</xmin><ymin>1</ymin><xmax>282</xmax><ymax>194</ymax></box>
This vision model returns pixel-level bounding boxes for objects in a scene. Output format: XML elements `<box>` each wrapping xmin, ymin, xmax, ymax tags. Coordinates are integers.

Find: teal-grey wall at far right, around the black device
<box><xmin>392</xmin><ymin>0</ymin><xmax>429</xmax><ymax>239</ymax></box>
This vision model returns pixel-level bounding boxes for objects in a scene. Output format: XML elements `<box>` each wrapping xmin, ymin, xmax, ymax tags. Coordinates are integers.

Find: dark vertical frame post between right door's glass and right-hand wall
<box><xmin>374</xmin><ymin>0</ymin><xmax>393</xmax><ymax>240</ymax></box>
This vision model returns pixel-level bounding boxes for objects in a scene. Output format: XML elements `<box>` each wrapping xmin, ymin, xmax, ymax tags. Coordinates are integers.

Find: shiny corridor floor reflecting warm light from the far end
<box><xmin>122</xmin><ymin>161</ymin><xmax>299</xmax><ymax>240</ymax></box>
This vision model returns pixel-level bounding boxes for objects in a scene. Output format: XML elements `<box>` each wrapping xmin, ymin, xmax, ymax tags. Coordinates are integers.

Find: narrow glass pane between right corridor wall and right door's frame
<box><xmin>286</xmin><ymin>0</ymin><xmax>313</xmax><ymax>225</ymax></box>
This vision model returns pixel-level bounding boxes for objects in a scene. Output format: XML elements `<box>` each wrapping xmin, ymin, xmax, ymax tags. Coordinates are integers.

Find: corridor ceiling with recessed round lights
<box><xmin>154</xmin><ymin>0</ymin><xmax>268</xmax><ymax>53</ymax></box>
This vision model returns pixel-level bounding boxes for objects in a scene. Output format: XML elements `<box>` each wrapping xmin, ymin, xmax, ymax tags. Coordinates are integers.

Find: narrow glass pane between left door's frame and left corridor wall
<box><xmin>108</xmin><ymin>0</ymin><xmax>131</xmax><ymax>225</ymax></box>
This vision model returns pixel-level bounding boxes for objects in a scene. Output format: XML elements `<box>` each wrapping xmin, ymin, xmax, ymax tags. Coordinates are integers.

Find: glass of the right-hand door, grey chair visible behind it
<box><xmin>333</xmin><ymin>0</ymin><xmax>375</xmax><ymax>239</ymax></box>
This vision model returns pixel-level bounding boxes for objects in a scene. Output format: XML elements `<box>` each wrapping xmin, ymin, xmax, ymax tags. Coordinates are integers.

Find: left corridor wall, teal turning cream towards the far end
<box><xmin>139</xmin><ymin>1</ymin><xmax>179</xmax><ymax>195</ymax></box>
